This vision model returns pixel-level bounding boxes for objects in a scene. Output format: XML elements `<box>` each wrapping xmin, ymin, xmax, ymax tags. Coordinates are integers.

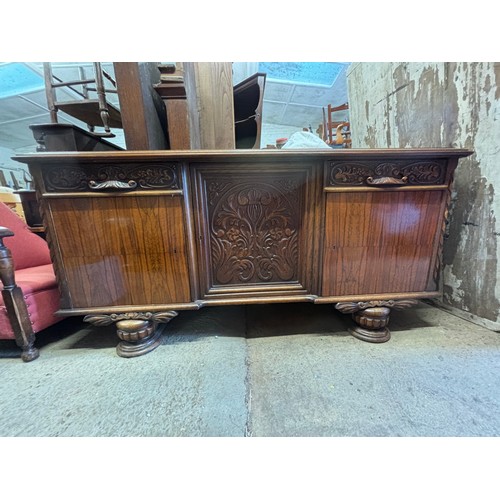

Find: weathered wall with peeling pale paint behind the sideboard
<box><xmin>347</xmin><ymin>62</ymin><xmax>500</xmax><ymax>330</ymax></box>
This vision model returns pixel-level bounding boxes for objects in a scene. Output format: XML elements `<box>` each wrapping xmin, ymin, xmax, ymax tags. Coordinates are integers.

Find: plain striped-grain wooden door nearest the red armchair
<box><xmin>49</xmin><ymin>193</ymin><xmax>191</xmax><ymax>308</ymax></box>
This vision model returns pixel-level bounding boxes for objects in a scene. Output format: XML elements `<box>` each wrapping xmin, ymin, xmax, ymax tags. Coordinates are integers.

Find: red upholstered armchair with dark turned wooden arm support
<box><xmin>0</xmin><ymin>203</ymin><xmax>62</xmax><ymax>361</ymax></box>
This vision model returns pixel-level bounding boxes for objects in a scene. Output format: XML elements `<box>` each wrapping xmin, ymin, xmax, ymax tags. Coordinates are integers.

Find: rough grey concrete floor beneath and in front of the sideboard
<box><xmin>0</xmin><ymin>304</ymin><xmax>500</xmax><ymax>437</ymax></box>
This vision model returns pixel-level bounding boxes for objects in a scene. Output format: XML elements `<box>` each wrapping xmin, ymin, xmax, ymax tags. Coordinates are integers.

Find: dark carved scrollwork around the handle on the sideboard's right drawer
<box><xmin>328</xmin><ymin>161</ymin><xmax>446</xmax><ymax>186</ymax></box>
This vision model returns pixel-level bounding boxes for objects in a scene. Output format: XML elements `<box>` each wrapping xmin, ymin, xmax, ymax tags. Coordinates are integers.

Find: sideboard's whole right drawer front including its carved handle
<box><xmin>325</xmin><ymin>159</ymin><xmax>448</xmax><ymax>188</ymax></box>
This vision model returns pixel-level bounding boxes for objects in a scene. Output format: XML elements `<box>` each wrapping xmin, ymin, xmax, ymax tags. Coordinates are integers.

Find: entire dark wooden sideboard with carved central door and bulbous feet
<box><xmin>15</xmin><ymin>149</ymin><xmax>472</xmax><ymax>357</ymax></box>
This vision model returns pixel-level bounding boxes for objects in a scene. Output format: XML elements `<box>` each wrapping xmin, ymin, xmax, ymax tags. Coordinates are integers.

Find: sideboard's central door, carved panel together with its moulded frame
<box><xmin>192</xmin><ymin>164</ymin><xmax>314</xmax><ymax>298</ymax></box>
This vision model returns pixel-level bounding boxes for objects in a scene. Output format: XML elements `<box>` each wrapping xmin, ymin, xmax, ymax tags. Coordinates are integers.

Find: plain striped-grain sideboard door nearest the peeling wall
<box><xmin>323</xmin><ymin>190</ymin><xmax>445</xmax><ymax>296</ymax></box>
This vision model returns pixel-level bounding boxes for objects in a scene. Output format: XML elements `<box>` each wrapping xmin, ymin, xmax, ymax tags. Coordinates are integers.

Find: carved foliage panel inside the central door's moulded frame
<box><xmin>200</xmin><ymin>172</ymin><xmax>305</xmax><ymax>286</ymax></box>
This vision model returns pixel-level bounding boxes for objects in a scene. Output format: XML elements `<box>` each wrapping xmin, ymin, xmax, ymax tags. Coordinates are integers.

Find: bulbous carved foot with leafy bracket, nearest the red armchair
<box><xmin>83</xmin><ymin>311</ymin><xmax>177</xmax><ymax>358</ymax></box>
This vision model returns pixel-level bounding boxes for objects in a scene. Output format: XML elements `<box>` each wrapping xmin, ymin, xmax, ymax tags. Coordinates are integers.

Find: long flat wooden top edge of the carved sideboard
<box><xmin>12</xmin><ymin>148</ymin><xmax>474</xmax><ymax>163</ymax></box>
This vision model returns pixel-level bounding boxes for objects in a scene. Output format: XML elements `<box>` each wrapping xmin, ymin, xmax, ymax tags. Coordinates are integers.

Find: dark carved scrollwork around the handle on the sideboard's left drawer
<box><xmin>43</xmin><ymin>163</ymin><xmax>181</xmax><ymax>192</ymax></box>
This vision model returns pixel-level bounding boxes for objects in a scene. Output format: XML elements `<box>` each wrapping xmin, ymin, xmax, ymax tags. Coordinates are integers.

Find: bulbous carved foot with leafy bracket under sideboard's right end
<box><xmin>335</xmin><ymin>299</ymin><xmax>418</xmax><ymax>343</ymax></box>
